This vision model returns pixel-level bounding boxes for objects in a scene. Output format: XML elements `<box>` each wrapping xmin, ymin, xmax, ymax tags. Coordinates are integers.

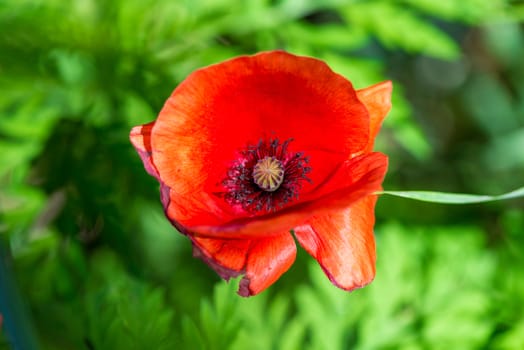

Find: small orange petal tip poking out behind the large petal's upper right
<box><xmin>357</xmin><ymin>80</ymin><xmax>393</xmax><ymax>152</ymax></box>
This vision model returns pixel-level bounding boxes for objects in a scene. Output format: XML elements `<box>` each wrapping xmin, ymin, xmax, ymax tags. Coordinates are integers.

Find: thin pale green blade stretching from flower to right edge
<box><xmin>378</xmin><ymin>187</ymin><xmax>524</xmax><ymax>204</ymax></box>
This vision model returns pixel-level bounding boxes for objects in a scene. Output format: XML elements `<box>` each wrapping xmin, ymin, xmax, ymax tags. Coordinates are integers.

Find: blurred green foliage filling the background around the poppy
<box><xmin>0</xmin><ymin>0</ymin><xmax>524</xmax><ymax>350</ymax></box>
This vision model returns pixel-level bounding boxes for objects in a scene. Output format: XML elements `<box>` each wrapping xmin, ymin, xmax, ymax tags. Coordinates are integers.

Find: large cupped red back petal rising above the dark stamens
<box><xmin>146</xmin><ymin>51</ymin><xmax>369</xmax><ymax>225</ymax></box>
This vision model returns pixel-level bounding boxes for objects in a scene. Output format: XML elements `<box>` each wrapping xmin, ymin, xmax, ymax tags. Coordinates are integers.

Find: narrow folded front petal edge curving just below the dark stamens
<box><xmin>186</xmin><ymin>152</ymin><xmax>387</xmax><ymax>238</ymax></box>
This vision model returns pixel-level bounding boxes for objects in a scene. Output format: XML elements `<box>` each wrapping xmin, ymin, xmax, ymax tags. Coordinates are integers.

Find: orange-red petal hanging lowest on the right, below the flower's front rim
<box><xmin>295</xmin><ymin>196</ymin><xmax>376</xmax><ymax>290</ymax></box>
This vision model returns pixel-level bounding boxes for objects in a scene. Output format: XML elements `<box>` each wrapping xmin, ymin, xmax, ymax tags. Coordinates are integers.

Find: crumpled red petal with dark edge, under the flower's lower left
<box><xmin>191</xmin><ymin>233</ymin><xmax>296</xmax><ymax>296</ymax></box>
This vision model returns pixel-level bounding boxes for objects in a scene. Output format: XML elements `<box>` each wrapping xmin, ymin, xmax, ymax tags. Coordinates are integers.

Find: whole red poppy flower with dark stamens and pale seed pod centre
<box><xmin>131</xmin><ymin>51</ymin><xmax>391</xmax><ymax>296</ymax></box>
